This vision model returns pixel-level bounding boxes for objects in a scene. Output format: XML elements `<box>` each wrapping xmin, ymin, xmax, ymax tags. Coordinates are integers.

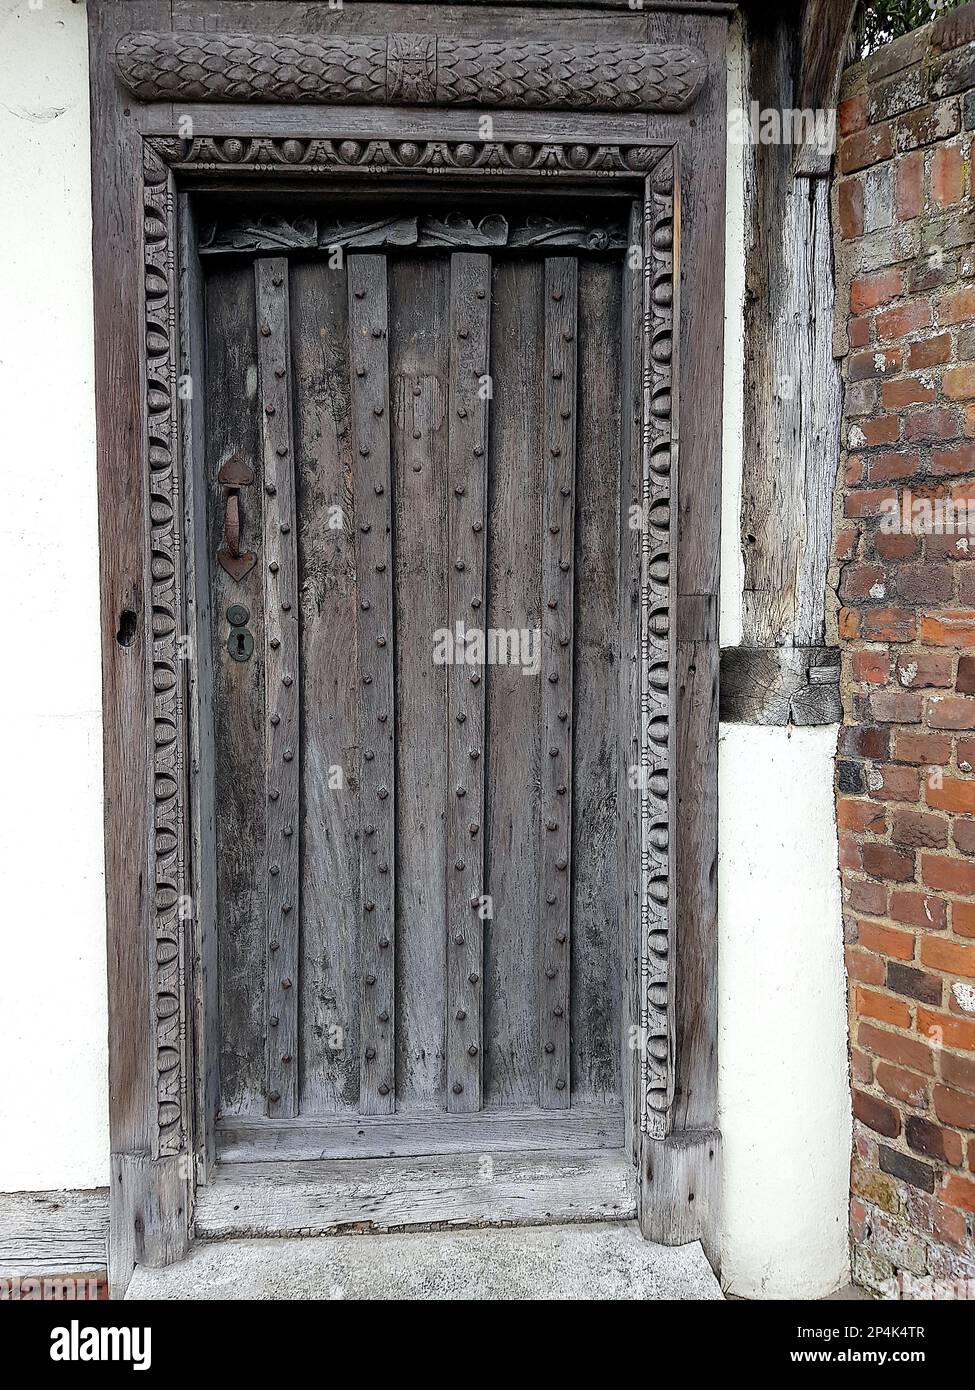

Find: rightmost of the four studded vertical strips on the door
<box><xmin>538</xmin><ymin>256</ymin><xmax>577</xmax><ymax>1109</ymax></box>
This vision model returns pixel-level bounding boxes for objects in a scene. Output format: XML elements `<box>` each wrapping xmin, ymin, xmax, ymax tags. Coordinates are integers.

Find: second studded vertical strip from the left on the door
<box><xmin>348</xmin><ymin>256</ymin><xmax>396</xmax><ymax>1115</ymax></box>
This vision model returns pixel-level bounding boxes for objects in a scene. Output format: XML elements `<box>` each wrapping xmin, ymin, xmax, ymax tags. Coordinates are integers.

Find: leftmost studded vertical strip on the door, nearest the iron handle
<box><xmin>255</xmin><ymin>257</ymin><xmax>300</xmax><ymax>1119</ymax></box>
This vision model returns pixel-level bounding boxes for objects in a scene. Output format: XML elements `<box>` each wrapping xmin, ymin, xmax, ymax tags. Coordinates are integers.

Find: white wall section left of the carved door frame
<box><xmin>0</xmin><ymin>0</ymin><xmax>108</xmax><ymax>1191</ymax></box>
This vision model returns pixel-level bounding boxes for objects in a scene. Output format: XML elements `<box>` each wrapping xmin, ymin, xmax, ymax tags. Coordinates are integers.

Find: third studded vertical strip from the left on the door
<box><xmin>446</xmin><ymin>253</ymin><xmax>491</xmax><ymax>1113</ymax></box>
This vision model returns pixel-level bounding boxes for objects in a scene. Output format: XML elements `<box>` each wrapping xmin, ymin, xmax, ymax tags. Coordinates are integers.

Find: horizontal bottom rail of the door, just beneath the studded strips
<box><xmin>217</xmin><ymin>1105</ymin><xmax>625</xmax><ymax>1163</ymax></box>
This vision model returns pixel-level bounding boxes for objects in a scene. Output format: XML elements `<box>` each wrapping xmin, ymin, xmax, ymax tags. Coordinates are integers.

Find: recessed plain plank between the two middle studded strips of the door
<box><xmin>389</xmin><ymin>257</ymin><xmax>449</xmax><ymax>1109</ymax></box>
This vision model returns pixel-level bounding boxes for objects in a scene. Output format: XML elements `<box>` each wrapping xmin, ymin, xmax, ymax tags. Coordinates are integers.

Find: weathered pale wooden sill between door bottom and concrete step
<box><xmin>195</xmin><ymin>1150</ymin><xmax>636</xmax><ymax>1240</ymax></box>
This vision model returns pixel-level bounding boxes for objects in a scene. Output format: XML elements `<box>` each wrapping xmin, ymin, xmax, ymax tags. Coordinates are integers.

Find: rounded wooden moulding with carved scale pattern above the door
<box><xmin>115</xmin><ymin>32</ymin><xmax>708</xmax><ymax>111</ymax></box>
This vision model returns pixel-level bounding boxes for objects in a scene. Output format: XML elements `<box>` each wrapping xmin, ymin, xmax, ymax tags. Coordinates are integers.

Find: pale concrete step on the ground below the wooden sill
<box><xmin>127</xmin><ymin>1222</ymin><xmax>723</xmax><ymax>1301</ymax></box>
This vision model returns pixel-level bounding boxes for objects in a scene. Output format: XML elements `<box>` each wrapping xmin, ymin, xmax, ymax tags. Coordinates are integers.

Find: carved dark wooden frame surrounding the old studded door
<box><xmin>90</xmin><ymin>0</ymin><xmax>730</xmax><ymax>1289</ymax></box>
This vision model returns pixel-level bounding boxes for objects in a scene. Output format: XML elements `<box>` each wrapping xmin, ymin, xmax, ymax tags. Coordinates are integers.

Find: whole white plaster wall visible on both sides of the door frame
<box><xmin>0</xmin><ymin>0</ymin><xmax>850</xmax><ymax>1297</ymax></box>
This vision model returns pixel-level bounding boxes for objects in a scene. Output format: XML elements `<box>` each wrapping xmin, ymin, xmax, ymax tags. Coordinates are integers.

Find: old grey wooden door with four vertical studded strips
<box><xmin>203</xmin><ymin>204</ymin><xmax>637</xmax><ymax>1158</ymax></box>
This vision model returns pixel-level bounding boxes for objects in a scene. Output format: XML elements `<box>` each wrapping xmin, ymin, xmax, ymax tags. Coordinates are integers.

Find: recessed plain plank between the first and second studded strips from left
<box><xmin>289</xmin><ymin>260</ymin><xmax>360</xmax><ymax>1115</ymax></box>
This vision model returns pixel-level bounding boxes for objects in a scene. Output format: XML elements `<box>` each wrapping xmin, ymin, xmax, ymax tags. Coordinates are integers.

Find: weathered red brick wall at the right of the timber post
<box><xmin>833</xmin><ymin>6</ymin><xmax>975</xmax><ymax>1297</ymax></box>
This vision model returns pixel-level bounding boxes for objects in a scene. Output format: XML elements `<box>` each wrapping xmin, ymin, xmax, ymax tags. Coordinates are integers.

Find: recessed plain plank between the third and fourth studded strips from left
<box><xmin>484</xmin><ymin>257</ymin><xmax>545</xmax><ymax>1106</ymax></box>
